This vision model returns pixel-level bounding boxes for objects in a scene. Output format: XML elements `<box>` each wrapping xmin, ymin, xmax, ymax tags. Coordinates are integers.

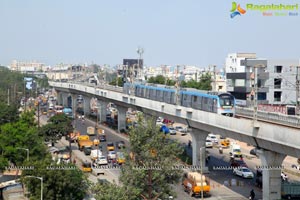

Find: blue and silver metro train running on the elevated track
<box><xmin>123</xmin><ymin>83</ymin><xmax>236</xmax><ymax>117</ymax></box>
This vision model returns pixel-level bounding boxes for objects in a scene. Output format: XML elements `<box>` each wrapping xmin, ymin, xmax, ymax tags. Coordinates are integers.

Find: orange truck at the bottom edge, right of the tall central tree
<box><xmin>182</xmin><ymin>172</ymin><xmax>210</xmax><ymax>196</ymax></box>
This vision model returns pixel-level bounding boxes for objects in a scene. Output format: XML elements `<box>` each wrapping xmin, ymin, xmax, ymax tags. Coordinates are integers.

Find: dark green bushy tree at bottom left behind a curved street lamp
<box><xmin>21</xmin><ymin>157</ymin><xmax>89</xmax><ymax>200</ymax></box>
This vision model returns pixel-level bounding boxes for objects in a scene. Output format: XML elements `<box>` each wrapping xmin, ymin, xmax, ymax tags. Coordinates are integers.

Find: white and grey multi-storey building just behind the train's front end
<box><xmin>225</xmin><ymin>53</ymin><xmax>269</xmax><ymax>106</ymax></box>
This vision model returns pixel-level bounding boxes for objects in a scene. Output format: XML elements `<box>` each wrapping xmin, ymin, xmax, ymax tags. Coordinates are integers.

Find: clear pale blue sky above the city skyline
<box><xmin>0</xmin><ymin>0</ymin><xmax>300</xmax><ymax>68</ymax></box>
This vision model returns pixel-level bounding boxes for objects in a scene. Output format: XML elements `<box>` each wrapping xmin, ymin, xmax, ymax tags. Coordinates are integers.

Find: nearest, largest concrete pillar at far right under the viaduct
<box><xmin>257</xmin><ymin>150</ymin><xmax>286</xmax><ymax>200</ymax></box>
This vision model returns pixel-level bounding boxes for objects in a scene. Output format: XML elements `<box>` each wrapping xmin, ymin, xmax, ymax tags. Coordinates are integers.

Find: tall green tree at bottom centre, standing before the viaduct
<box><xmin>120</xmin><ymin>115</ymin><xmax>183</xmax><ymax>200</ymax></box>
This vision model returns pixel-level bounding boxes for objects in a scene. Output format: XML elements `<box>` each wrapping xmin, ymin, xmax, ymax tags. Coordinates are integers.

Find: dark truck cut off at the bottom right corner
<box><xmin>281</xmin><ymin>182</ymin><xmax>300</xmax><ymax>199</ymax></box>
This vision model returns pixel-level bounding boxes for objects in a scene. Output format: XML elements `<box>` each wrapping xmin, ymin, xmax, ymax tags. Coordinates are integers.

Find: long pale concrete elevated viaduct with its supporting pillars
<box><xmin>50</xmin><ymin>82</ymin><xmax>300</xmax><ymax>200</ymax></box>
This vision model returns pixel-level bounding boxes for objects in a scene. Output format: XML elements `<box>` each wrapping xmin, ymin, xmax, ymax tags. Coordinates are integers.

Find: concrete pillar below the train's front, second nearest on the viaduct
<box><xmin>191</xmin><ymin>129</ymin><xmax>208</xmax><ymax>172</ymax></box>
